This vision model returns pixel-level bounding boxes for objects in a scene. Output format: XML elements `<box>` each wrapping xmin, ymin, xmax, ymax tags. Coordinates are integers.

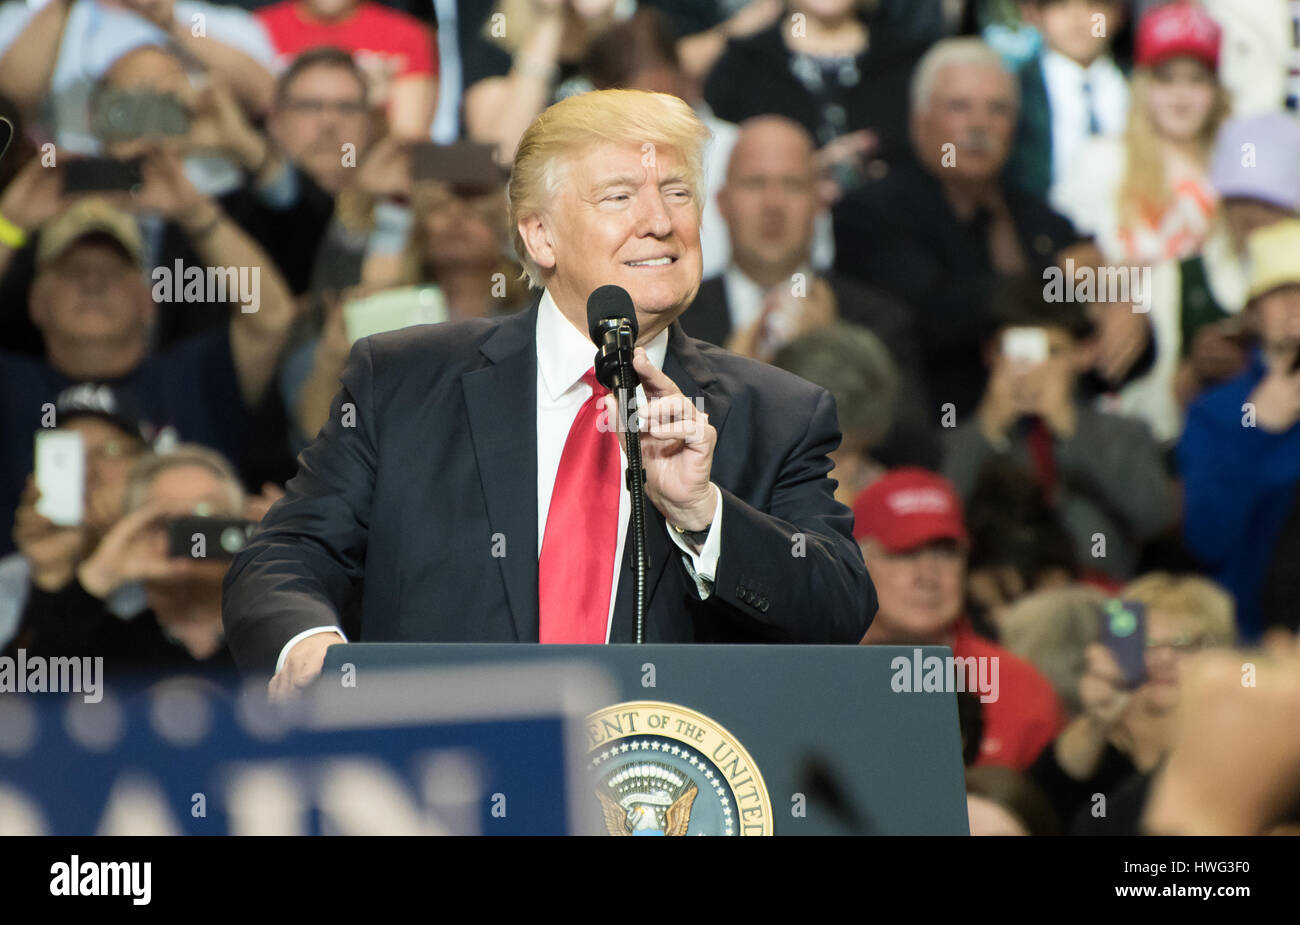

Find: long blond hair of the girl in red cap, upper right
<box><xmin>1117</xmin><ymin>68</ymin><xmax>1231</xmax><ymax>229</ymax></box>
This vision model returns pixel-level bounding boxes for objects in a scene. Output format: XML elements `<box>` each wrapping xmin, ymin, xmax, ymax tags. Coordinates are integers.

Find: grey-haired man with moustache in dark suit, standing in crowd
<box><xmin>833</xmin><ymin>38</ymin><xmax>1079</xmax><ymax>421</ymax></box>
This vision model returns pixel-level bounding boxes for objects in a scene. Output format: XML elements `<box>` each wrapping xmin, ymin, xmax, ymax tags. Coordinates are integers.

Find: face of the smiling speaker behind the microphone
<box><xmin>520</xmin><ymin>142</ymin><xmax>703</xmax><ymax>342</ymax></box>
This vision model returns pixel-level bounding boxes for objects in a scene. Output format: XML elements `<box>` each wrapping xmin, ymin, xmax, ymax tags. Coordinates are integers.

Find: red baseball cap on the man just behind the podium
<box><xmin>853</xmin><ymin>466</ymin><xmax>967</xmax><ymax>552</ymax></box>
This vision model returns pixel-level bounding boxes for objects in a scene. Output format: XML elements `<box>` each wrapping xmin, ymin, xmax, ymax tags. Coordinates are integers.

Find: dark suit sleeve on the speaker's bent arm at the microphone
<box><xmin>706</xmin><ymin>391</ymin><xmax>876</xmax><ymax>643</ymax></box>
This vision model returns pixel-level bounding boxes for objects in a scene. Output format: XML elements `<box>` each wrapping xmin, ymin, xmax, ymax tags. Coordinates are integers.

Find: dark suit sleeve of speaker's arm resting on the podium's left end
<box><xmin>221</xmin><ymin>339</ymin><xmax>377</xmax><ymax>674</ymax></box>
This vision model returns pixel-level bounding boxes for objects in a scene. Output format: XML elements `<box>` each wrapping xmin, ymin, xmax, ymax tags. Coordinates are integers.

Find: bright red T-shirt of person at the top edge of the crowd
<box><xmin>256</xmin><ymin>0</ymin><xmax>438</xmax><ymax>79</ymax></box>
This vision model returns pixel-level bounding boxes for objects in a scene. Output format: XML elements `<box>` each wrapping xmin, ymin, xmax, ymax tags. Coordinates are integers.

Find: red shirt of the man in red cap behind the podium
<box><xmin>953</xmin><ymin>618</ymin><xmax>1065</xmax><ymax>770</ymax></box>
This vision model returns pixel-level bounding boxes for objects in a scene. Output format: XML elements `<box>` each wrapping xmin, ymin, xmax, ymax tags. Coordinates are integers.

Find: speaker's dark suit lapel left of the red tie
<box><xmin>460</xmin><ymin>301</ymin><xmax>538</xmax><ymax>642</ymax></box>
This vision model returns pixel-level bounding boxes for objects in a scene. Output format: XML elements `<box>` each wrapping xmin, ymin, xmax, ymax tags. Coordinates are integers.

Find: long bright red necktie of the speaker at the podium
<box><xmin>537</xmin><ymin>369</ymin><xmax>621</xmax><ymax>643</ymax></box>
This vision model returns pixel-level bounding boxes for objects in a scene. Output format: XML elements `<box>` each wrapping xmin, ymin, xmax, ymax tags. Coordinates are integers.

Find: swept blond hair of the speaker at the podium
<box><xmin>507</xmin><ymin>90</ymin><xmax>710</xmax><ymax>288</ymax></box>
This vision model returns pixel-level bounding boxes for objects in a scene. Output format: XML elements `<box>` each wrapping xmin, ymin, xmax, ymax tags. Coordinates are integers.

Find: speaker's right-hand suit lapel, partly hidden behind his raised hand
<box><xmin>610</xmin><ymin>322</ymin><xmax>731</xmax><ymax>642</ymax></box>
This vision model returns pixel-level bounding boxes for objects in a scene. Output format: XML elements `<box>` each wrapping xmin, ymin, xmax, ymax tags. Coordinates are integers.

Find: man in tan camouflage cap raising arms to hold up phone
<box><xmin>0</xmin><ymin>163</ymin><xmax>293</xmax><ymax>561</ymax></box>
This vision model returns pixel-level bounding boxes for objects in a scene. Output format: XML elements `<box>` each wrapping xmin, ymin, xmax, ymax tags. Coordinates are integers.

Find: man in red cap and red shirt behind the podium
<box><xmin>853</xmin><ymin>468</ymin><xmax>1065</xmax><ymax>770</ymax></box>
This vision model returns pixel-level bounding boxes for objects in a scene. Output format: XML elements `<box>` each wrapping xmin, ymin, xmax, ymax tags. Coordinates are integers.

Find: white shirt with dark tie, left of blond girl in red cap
<box><xmin>1043</xmin><ymin>49</ymin><xmax>1128</xmax><ymax>193</ymax></box>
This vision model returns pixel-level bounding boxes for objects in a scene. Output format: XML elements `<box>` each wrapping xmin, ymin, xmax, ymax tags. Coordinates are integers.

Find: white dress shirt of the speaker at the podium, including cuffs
<box><xmin>276</xmin><ymin>292</ymin><xmax>723</xmax><ymax>672</ymax></box>
